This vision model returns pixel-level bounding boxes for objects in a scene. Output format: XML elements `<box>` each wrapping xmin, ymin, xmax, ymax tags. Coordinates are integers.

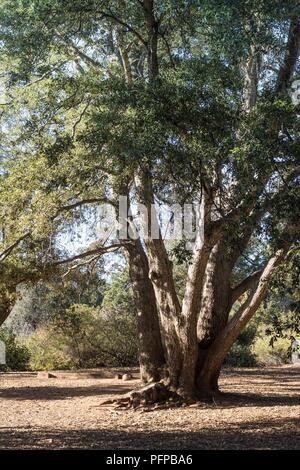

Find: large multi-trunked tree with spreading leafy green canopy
<box><xmin>0</xmin><ymin>0</ymin><xmax>300</xmax><ymax>404</ymax></box>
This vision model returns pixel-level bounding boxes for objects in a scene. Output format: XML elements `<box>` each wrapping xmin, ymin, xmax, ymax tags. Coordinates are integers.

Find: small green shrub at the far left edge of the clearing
<box><xmin>0</xmin><ymin>327</ymin><xmax>30</xmax><ymax>371</ymax></box>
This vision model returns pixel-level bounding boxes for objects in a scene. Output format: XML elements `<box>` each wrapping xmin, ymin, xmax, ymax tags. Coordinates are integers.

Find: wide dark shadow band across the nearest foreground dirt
<box><xmin>0</xmin><ymin>418</ymin><xmax>300</xmax><ymax>450</ymax></box>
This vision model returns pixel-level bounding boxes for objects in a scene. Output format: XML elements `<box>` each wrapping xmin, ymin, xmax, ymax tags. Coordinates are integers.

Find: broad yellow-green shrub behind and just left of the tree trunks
<box><xmin>26</xmin><ymin>304</ymin><xmax>138</xmax><ymax>370</ymax></box>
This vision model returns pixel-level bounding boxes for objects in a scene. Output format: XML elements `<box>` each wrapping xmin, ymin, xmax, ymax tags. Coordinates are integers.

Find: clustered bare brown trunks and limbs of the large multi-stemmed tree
<box><xmin>0</xmin><ymin>0</ymin><xmax>300</xmax><ymax>408</ymax></box>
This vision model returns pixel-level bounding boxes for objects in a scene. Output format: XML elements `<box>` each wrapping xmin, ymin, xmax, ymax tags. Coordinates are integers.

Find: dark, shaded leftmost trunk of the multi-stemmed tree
<box><xmin>126</xmin><ymin>240</ymin><xmax>165</xmax><ymax>383</ymax></box>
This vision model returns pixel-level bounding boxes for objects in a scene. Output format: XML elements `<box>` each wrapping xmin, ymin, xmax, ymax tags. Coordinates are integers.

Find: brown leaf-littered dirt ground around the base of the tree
<box><xmin>0</xmin><ymin>366</ymin><xmax>300</xmax><ymax>450</ymax></box>
